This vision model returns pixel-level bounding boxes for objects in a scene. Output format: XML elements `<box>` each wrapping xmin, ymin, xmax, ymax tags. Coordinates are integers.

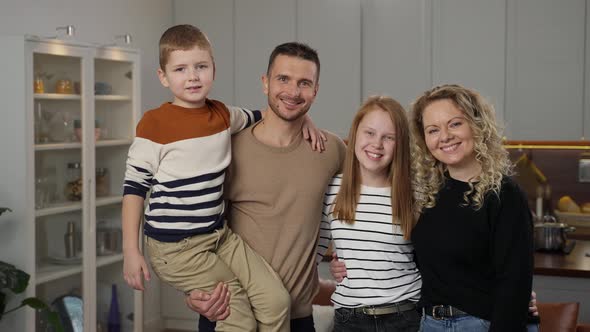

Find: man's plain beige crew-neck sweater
<box><xmin>226</xmin><ymin>126</ymin><xmax>346</xmax><ymax>319</ymax></box>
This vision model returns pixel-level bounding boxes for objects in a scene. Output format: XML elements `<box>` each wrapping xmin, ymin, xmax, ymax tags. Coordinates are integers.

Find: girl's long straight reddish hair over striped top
<box><xmin>333</xmin><ymin>96</ymin><xmax>414</xmax><ymax>240</ymax></box>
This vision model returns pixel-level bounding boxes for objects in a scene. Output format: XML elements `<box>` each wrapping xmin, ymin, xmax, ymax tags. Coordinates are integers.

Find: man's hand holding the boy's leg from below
<box><xmin>185</xmin><ymin>282</ymin><xmax>230</xmax><ymax>322</ymax></box>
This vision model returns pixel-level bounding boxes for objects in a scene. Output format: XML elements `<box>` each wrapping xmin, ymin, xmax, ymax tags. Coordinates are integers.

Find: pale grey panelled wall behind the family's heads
<box><xmin>174</xmin><ymin>0</ymin><xmax>590</xmax><ymax>140</ymax></box>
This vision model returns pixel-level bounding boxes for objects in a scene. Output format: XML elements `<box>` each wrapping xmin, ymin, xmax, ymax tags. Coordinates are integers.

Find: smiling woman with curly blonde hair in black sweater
<box><xmin>411</xmin><ymin>85</ymin><xmax>533</xmax><ymax>331</ymax></box>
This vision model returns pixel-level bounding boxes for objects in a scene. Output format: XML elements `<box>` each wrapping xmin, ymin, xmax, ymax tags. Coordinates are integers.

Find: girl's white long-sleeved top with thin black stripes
<box><xmin>318</xmin><ymin>174</ymin><xmax>422</xmax><ymax>308</ymax></box>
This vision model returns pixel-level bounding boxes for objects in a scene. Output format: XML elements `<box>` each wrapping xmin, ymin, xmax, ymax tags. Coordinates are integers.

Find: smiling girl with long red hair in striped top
<box><xmin>318</xmin><ymin>96</ymin><xmax>421</xmax><ymax>332</ymax></box>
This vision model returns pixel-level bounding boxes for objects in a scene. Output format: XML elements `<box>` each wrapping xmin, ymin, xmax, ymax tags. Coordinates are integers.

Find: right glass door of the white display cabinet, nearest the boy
<box><xmin>94</xmin><ymin>51</ymin><xmax>135</xmax><ymax>332</ymax></box>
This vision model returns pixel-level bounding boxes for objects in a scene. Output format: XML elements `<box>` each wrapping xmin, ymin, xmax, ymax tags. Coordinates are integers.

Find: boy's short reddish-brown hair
<box><xmin>160</xmin><ymin>24</ymin><xmax>213</xmax><ymax>70</ymax></box>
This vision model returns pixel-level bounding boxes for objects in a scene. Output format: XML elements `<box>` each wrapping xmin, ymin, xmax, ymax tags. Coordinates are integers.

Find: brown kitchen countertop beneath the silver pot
<box><xmin>534</xmin><ymin>240</ymin><xmax>590</xmax><ymax>278</ymax></box>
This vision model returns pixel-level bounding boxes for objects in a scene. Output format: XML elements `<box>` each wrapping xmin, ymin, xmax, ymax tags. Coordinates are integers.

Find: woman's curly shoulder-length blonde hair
<box><xmin>410</xmin><ymin>85</ymin><xmax>512</xmax><ymax>213</ymax></box>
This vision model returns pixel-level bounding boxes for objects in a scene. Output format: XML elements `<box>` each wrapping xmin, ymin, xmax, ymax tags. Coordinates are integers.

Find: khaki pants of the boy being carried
<box><xmin>146</xmin><ymin>225</ymin><xmax>291</xmax><ymax>332</ymax></box>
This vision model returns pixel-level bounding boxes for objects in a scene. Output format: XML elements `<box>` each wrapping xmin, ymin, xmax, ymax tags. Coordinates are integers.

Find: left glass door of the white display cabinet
<box><xmin>30</xmin><ymin>49</ymin><xmax>88</xmax><ymax>331</ymax></box>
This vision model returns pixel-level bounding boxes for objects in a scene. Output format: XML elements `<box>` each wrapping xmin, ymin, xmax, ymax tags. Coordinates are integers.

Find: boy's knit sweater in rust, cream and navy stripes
<box><xmin>123</xmin><ymin>100</ymin><xmax>260</xmax><ymax>242</ymax></box>
